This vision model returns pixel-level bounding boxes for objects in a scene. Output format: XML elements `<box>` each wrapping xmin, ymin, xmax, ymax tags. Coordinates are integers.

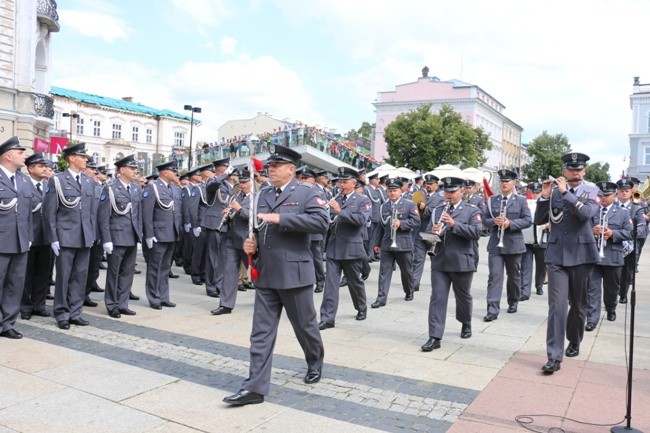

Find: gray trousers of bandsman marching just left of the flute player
<box><xmin>487</xmin><ymin>253</ymin><xmax>522</xmax><ymax>316</ymax></box>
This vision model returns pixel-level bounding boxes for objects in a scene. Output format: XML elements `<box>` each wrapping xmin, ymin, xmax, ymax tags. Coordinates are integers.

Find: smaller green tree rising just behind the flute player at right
<box><xmin>524</xmin><ymin>131</ymin><xmax>571</xmax><ymax>181</ymax></box>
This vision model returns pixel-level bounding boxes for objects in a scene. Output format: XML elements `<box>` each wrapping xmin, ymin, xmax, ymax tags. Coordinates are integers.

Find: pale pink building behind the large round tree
<box><xmin>373</xmin><ymin>71</ymin><xmax>523</xmax><ymax>169</ymax></box>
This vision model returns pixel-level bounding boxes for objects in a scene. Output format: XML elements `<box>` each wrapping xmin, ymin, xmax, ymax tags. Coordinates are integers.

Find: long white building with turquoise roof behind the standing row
<box><xmin>52</xmin><ymin>87</ymin><xmax>195</xmax><ymax>174</ymax></box>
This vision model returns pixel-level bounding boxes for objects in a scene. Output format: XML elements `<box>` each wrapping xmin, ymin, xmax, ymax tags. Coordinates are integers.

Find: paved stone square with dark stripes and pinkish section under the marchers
<box><xmin>0</xmin><ymin>236</ymin><xmax>650</xmax><ymax>433</ymax></box>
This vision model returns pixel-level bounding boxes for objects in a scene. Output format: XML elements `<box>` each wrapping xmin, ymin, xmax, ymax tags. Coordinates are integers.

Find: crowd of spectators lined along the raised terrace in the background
<box><xmin>193</xmin><ymin>122</ymin><xmax>380</xmax><ymax>171</ymax></box>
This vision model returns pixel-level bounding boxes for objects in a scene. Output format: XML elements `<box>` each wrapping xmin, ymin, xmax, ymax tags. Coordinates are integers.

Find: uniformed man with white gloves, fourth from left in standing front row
<box><xmin>97</xmin><ymin>155</ymin><xmax>142</xmax><ymax>319</ymax></box>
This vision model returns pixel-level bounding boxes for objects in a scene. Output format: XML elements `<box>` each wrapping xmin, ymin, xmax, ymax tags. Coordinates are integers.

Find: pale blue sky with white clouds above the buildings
<box><xmin>51</xmin><ymin>0</ymin><xmax>650</xmax><ymax>178</ymax></box>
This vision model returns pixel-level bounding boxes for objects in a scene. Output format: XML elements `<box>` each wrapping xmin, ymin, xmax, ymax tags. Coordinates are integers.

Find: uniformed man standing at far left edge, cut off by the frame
<box><xmin>0</xmin><ymin>137</ymin><xmax>33</xmax><ymax>340</ymax></box>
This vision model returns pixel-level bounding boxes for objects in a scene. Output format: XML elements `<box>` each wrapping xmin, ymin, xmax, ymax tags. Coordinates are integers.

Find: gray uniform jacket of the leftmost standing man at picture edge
<box><xmin>0</xmin><ymin>170</ymin><xmax>35</xmax><ymax>251</ymax></box>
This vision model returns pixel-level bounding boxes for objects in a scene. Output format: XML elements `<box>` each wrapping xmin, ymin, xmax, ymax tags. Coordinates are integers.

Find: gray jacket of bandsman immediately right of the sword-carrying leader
<box><xmin>326</xmin><ymin>192</ymin><xmax>372</xmax><ymax>260</ymax></box>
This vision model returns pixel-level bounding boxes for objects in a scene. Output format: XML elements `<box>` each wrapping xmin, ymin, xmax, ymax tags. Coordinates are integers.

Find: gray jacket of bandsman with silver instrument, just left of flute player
<box><xmin>483</xmin><ymin>193</ymin><xmax>533</xmax><ymax>254</ymax></box>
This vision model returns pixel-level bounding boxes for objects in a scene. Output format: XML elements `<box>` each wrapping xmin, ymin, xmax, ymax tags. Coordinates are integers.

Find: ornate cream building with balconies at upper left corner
<box><xmin>0</xmin><ymin>0</ymin><xmax>59</xmax><ymax>148</ymax></box>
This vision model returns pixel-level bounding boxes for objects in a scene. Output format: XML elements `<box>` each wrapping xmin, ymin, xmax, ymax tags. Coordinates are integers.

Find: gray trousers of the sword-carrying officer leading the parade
<box><xmin>242</xmin><ymin>284</ymin><xmax>325</xmax><ymax>395</ymax></box>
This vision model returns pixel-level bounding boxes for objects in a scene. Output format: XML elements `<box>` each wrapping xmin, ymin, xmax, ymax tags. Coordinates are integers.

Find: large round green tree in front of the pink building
<box><xmin>384</xmin><ymin>104</ymin><xmax>492</xmax><ymax>171</ymax></box>
